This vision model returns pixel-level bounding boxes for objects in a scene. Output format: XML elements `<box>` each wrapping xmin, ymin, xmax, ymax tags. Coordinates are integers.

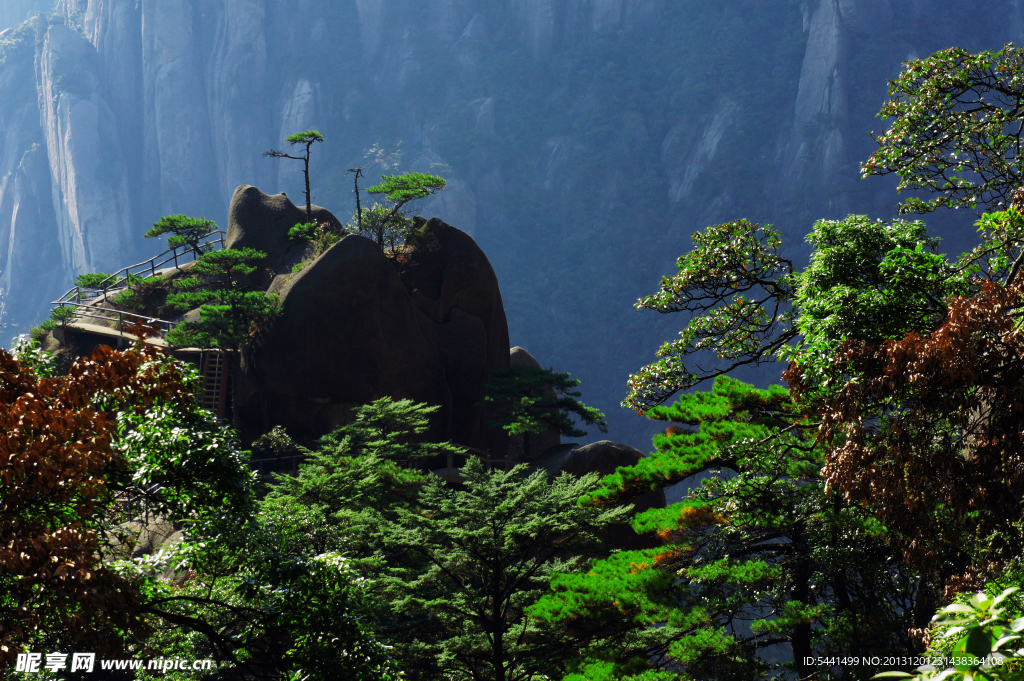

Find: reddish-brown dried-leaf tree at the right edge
<box><xmin>786</xmin><ymin>282</ymin><xmax>1024</xmax><ymax>578</ymax></box>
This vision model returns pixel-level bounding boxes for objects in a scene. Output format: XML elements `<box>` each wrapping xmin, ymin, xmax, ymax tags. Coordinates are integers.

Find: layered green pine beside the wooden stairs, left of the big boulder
<box><xmin>167</xmin><ymin>248</ymin><xmax>280</xmax><ymax>350</ymax></box>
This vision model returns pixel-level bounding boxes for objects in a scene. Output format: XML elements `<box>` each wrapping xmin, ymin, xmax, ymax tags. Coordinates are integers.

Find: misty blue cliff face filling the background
<box><xmin>0</xmin><ymin>0</ymin><xmax>1024</xmax><ymax>448</ymax></box>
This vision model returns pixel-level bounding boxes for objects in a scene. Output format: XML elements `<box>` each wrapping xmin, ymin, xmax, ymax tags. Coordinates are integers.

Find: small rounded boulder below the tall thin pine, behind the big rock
<box><xmin>224</xmin><ymin>184</ymin><xmax>341</xmax><ymax>290</ymax></box>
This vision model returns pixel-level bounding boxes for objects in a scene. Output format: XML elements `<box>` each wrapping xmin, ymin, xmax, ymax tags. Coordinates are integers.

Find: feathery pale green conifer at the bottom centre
<box><xmin>378</xmin><ymin>458</ymin><xmax>630</xmax><ymax>681</ymax></box>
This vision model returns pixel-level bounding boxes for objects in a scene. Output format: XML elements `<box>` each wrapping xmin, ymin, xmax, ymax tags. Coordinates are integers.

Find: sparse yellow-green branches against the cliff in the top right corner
<box><xmin>861</xmin><ymin>44</ymin><xmax>1024</xmax><ymax>213</ymax></box>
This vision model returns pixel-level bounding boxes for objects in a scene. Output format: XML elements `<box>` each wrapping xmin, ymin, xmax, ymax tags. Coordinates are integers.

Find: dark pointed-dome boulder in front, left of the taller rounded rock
<box><xmin>236</xmin><ymin>233</ymin><xmax>452</xmax><ymax>440</ymax></box>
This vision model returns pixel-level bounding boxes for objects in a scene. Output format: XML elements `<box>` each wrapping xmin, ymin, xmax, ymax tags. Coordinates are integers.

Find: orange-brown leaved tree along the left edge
<box><xmin>0</xmin><ymin>330</ymin><xmax>191</xmax><ymax>666</ymax></box>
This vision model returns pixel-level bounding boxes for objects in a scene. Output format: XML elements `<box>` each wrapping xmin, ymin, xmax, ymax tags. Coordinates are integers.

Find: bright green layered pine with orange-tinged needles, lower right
<box><xmin>534</xmin><ymin>376</ymin><xmax>915</xmax><ymax>679</ymax></box>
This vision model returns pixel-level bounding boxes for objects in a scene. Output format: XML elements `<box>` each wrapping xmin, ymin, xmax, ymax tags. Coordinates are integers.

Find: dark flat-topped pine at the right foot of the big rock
<box><xmin>481</xmin><ymin>367</ymin><xmax>608</xmax><ymax>458</ymax></box>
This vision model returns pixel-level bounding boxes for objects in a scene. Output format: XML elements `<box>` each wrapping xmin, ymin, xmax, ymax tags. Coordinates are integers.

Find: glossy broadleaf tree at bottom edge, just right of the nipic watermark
<box><xmin>134</xmin><ymin>536</ymin><xmax>400</xmax><ymax>681</ymax></box>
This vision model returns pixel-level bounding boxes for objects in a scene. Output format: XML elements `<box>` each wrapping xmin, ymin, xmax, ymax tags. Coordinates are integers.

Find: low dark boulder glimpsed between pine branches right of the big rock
<box><xmin>531</xmin><ymin>440</ymin><xmax>665</xmax><ymax>549</ymax></box>
